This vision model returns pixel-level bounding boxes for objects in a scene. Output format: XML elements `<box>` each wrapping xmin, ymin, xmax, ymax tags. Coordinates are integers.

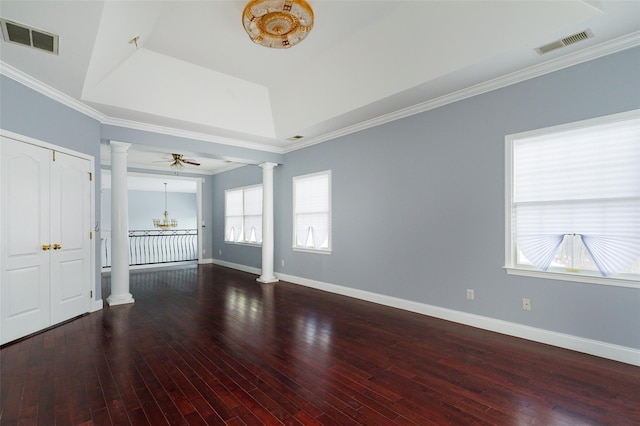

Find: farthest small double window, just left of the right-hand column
<box><xmin>224</xmin><ymin>185</ymin><xmax>262</xmax><ymax>244</ymax></box>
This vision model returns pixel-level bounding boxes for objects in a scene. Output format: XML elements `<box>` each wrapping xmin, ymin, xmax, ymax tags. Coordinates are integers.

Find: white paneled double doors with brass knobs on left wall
<box><xmin>0</xmin><ymin>136</ymin><xmax>93</xmax><ymax>344</ymax></box>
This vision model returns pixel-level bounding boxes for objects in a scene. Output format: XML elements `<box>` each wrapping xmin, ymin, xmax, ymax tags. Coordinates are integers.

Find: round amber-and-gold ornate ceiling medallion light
<box><xmin>242</xmin><ymin>0</ymin><xmax>313</xmax><ymax>49</ymax></box>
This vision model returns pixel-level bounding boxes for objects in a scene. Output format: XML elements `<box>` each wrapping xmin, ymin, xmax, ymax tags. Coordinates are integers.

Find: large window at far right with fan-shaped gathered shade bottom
<box><xmin>506</xmin><ymin>111</ymin><xmax>640</xmax><ymax>286</ymax></box>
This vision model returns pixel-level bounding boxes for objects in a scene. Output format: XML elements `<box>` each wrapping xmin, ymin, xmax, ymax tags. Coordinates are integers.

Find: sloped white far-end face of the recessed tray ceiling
<box><xmin>83</xmin><ymin>49</ymin><xmax>275</xmax><ymax>137</ymax></box>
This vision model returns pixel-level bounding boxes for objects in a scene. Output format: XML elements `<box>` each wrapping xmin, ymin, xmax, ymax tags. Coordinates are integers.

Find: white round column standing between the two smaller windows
<box><xmin>258</xmin><ymin>163</ymin><xmax>278</xmax><ymax>283</ymax></box>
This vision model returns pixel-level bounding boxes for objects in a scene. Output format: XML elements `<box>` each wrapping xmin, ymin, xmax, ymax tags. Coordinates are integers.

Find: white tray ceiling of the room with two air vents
<box><xmin>0</xmin><ymin>0</ymin><xmax>640</xmax><ymax>170</ymax></box>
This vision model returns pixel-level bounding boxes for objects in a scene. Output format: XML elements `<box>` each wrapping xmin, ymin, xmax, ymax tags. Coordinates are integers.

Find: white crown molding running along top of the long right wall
<box><xmin>284</xmin><ymin>31</ymin><xmax>640</xmax><ymax>154</ymax></box>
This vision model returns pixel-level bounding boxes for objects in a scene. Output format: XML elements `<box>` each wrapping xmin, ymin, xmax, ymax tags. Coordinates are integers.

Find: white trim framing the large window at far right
<box><xmin>503</xmin><ymin>109</ymin><xmax>640</xmax><ymax>288</ymax></box>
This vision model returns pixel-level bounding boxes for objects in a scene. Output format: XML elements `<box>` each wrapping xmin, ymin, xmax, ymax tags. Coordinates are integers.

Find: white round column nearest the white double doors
<box><xmin>107</xmin><ymin>141</ymin><xmax>134</xmax><ymax>306</ymax></box>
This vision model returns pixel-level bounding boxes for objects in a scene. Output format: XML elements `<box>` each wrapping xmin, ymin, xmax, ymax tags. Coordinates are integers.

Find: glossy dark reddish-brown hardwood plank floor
<box><xmin>0</xmin><ymin>265</ymin><xmax>640</xmax><ymax>426</ymax></box>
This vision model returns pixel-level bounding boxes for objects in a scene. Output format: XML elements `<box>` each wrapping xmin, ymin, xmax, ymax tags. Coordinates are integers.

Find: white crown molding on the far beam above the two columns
<box><xmin>102</xmin><ymin>117</ymin><xmax>284</xmax><ymax>154</ymax></box>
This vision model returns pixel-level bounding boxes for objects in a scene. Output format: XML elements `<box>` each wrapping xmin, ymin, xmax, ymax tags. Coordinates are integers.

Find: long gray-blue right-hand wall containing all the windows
<box><xmin>213</xmin><ymin>48</ymin><xmax>640</xmax><ymax>348</ymax></box>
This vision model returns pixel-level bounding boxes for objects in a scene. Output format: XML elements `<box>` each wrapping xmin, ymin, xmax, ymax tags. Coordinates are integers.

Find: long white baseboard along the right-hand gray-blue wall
<box><xmin>276</xmin><ymin>272</ymin><xmax>640</xmax><ymax>366</ymax></box>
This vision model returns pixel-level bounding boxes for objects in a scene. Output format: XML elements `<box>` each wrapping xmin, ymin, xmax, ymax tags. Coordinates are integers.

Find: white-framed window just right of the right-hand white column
<box><xmin>293</xmin><ymin>171</ymin><xmax>331</xmax><ymax>253</ymax></box>
